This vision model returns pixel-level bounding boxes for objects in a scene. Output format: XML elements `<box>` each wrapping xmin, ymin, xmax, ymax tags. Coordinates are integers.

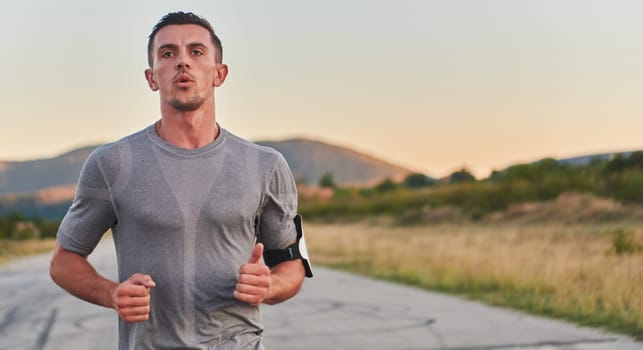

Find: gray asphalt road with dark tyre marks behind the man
<box><xmin>0</xmin><ymin>240</ymin><xmax>643</xmax><ymax>350</ymax></box>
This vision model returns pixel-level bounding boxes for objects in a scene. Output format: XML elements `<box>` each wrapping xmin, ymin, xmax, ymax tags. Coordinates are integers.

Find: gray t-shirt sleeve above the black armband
<box><xmin>258</xmin><ymin>154</ymin><xmax>297</xmax><ymax>249</ymax></box>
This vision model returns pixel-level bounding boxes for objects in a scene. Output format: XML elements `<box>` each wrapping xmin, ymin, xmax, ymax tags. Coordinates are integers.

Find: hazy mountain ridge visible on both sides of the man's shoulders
<box><xmin>0</xmin><ymin>139</ymin><xmax>411</xmax><ymax>197</ymax></box>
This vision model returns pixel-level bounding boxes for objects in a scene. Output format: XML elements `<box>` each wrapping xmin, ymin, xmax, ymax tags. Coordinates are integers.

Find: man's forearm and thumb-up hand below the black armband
<box><xmin>234</xmin><ymin>243</ymin><xmax>305</xmax><ymax>306</ymax></box>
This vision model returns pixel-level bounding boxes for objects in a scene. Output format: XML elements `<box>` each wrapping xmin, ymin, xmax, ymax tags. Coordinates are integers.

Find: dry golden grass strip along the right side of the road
<box><xmin>306</xmin><ymin>223</ymin><xmax>643</xmax><ymax>340</ymax></box>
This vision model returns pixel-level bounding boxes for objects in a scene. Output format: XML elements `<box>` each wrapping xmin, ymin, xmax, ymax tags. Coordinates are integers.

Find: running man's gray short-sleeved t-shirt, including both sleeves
<box><xmin>58</xmin><ymin>125</ymin><xmax>297</xmax><ymax>349</ymax></box>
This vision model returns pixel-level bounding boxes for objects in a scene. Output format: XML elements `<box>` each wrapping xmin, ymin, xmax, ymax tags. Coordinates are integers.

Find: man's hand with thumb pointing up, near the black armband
<box><xmin>233</xmin><ymin>243</ymin><xmax>271</xmax><ymax>306</ymax></box>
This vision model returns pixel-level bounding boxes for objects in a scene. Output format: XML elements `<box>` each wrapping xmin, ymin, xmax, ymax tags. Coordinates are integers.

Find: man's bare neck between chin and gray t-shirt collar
<box><xmin>155</xmin><ymin>110</ymin><xmax>219</xmax><ymax>149</ymax></box>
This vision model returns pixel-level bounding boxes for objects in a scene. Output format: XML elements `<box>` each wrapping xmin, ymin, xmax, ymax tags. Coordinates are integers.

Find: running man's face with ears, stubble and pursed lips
<box><xmin>145</xmin><ymin>24</ymin><xmax>227</xmax><ymax>111</ymax></box>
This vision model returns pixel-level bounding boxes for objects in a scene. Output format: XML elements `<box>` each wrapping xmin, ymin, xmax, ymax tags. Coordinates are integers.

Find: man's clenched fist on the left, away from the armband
<box><xmin>112</xmin><ymin>273</ymin><xmax>156</xmax><ymax>322</ymax></box>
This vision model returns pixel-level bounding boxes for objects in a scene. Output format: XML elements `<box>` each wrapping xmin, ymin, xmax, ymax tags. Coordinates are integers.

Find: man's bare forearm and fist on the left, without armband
<box><xmin>49</xmin><ymin>242</ymin><xmax>155</xmax><ymax>322</ymax></box>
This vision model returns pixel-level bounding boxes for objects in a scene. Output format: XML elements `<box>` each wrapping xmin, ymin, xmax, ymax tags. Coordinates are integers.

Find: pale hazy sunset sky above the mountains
<box><xmin>0</xmin><ymin>0</ymin><xmax>643</xmax><ymax>177</ymax></box>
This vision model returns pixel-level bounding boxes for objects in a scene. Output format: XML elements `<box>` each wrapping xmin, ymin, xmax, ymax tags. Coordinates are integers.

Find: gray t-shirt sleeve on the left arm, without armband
<box><xmin>56</xmin><ymin>151</ymin><xmax>116</xmax><ymax>256</ymax></box>
